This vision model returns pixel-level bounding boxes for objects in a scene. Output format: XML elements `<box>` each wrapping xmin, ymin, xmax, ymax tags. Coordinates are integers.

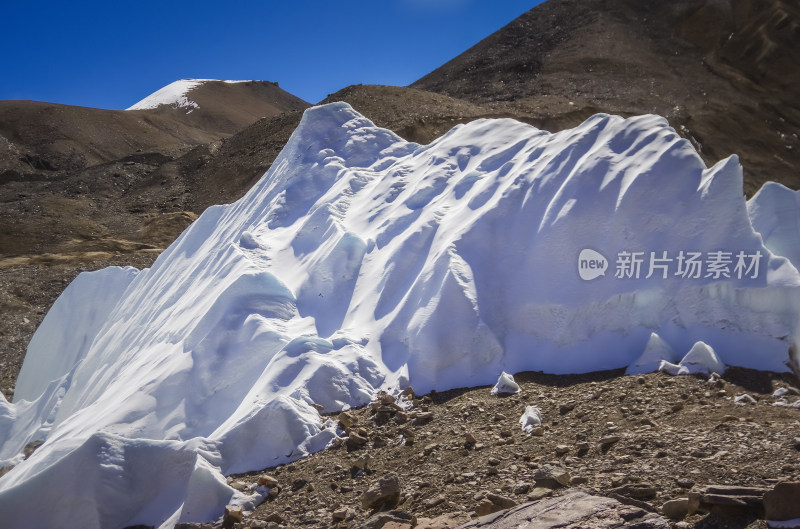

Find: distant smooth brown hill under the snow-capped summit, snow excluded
<box><xmin>0</xmin><ymin>81</ymin><xmax>309</xmax><ymax>177</ymax></box>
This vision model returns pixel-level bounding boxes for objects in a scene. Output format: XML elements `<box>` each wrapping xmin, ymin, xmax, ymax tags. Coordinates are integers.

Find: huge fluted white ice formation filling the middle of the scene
<box><xmin>0</xmin><ymin>103</ymin><xmax>800</xmax><ymax>529</ymax></box>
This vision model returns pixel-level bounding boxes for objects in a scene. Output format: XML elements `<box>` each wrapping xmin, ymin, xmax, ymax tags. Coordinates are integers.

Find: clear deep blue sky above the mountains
<box><xmin>0</xmin><ymin>0</ymin><xmax>541</xmax><ymax>109</ymax></box>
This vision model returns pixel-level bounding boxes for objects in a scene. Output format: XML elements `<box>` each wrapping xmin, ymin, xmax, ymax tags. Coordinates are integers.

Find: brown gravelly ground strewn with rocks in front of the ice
<box><xmin>166</xmin><ymin>368</ymin><xmax>800</xmax><ymax>529</ymax></box>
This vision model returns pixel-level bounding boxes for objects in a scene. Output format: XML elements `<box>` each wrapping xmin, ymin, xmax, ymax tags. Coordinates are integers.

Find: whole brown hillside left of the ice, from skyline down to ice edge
<box><xmin>0</xmin><ymin>81</ymin><xmax>309</xmax><ymax>395</ymax></box>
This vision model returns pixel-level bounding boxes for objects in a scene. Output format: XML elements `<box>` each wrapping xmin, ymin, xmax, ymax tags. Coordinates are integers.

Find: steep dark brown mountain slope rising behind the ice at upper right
<box><xmin>412</xmin><ymin>0</ymin><xmax>800</xmax><ymax>194</ymax></box>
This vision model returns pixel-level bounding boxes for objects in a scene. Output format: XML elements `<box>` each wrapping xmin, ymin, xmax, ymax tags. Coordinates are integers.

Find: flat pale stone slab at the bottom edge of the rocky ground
<box><xmin>459</xmin><ymin>489</ymin><xmax>670</xmax><ymax>529</ymax></box>
